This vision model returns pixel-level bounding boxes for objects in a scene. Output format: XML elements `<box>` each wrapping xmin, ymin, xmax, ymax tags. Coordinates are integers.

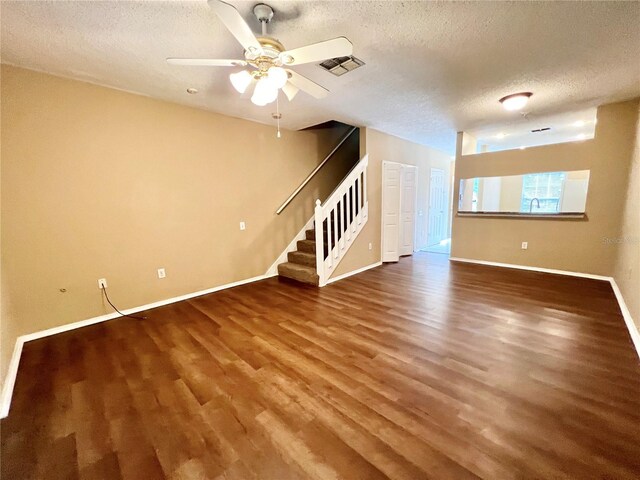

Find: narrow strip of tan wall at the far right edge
<box><xmin>613</xmin><ymin>105</ymin><xmax>640</xmax><ymax>329</ymax></box>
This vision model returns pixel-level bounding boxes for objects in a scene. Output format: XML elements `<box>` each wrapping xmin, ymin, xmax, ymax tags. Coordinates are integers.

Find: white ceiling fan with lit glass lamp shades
<box><xmin>167</xmin><ymin>0</ymin><xmax>353</xmax><ymax>106</ymax></box>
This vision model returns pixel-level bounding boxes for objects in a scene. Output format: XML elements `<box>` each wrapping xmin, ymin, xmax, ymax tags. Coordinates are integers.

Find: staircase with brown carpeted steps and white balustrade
<box><xmin>278</xmin><ymin>155</ymin><xmax>369</xmax><ymax>287</ymax></box>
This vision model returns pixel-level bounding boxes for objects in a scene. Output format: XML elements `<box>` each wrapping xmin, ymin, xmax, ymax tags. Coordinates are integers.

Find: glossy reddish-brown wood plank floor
<box><xmin>1</xmin><ymin>253</ymin><xmax>640</xmax><ymax>480</ymax></box>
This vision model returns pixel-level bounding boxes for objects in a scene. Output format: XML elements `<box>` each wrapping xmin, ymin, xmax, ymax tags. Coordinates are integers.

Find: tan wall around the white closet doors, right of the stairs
<box><xmin>332</xmin><ymin>128</ymin><xmax>451</xmax><ymax>276</ymax></box>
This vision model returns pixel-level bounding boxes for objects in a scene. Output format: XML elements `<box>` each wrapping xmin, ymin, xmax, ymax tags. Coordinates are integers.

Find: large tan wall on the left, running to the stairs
<box><xmin>1</xmin><ymin>66</ymin><xmax>356</xmax><ymax>390</ymax></box>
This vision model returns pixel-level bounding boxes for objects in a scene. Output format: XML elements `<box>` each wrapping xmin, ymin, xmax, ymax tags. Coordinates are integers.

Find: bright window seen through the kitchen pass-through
<box><xmin>520</xmin><ymin>172</ymin><xmax>566</xmax><ymax>213</ymax></box>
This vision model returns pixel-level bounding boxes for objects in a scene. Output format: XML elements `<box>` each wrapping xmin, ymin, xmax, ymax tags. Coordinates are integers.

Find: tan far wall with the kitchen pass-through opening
<box><xmin>451</xmin><ymin>100</ymin><xmax>638</xmax><ymax>276</ymax></box>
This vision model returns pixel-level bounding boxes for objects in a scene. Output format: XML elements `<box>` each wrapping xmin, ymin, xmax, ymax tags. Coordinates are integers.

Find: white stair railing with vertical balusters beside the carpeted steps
<box><xmin>315</xmin><ymin>155</ymin><xmax>369</xmax><ymax>287</ymax></box>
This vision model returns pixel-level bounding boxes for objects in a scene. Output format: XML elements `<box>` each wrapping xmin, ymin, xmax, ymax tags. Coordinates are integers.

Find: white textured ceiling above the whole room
<box><xmin>1</xmin><ymin>0</ymin><xmax>640</xmax><ymax>153</ymax></box>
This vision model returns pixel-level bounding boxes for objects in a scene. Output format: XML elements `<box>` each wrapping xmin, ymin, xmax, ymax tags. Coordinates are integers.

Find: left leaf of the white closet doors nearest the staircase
<box><xmin>382</xmin><ymin>162</ymin><xmax>401</xmax><ymax>262</ymax></box>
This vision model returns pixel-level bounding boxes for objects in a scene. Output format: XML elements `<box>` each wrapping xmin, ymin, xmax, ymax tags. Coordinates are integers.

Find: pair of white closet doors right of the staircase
<box><xmin>382</xmin><ymin>161</ymin><xmax>418</xmax><ymax>262</ymax></box>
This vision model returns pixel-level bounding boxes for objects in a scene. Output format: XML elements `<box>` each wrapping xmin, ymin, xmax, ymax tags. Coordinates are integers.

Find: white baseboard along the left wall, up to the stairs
<box><xmin>0</xmin><ymin>274</ymin><xmax>275</xmax><ymax>418</ymax></box>
